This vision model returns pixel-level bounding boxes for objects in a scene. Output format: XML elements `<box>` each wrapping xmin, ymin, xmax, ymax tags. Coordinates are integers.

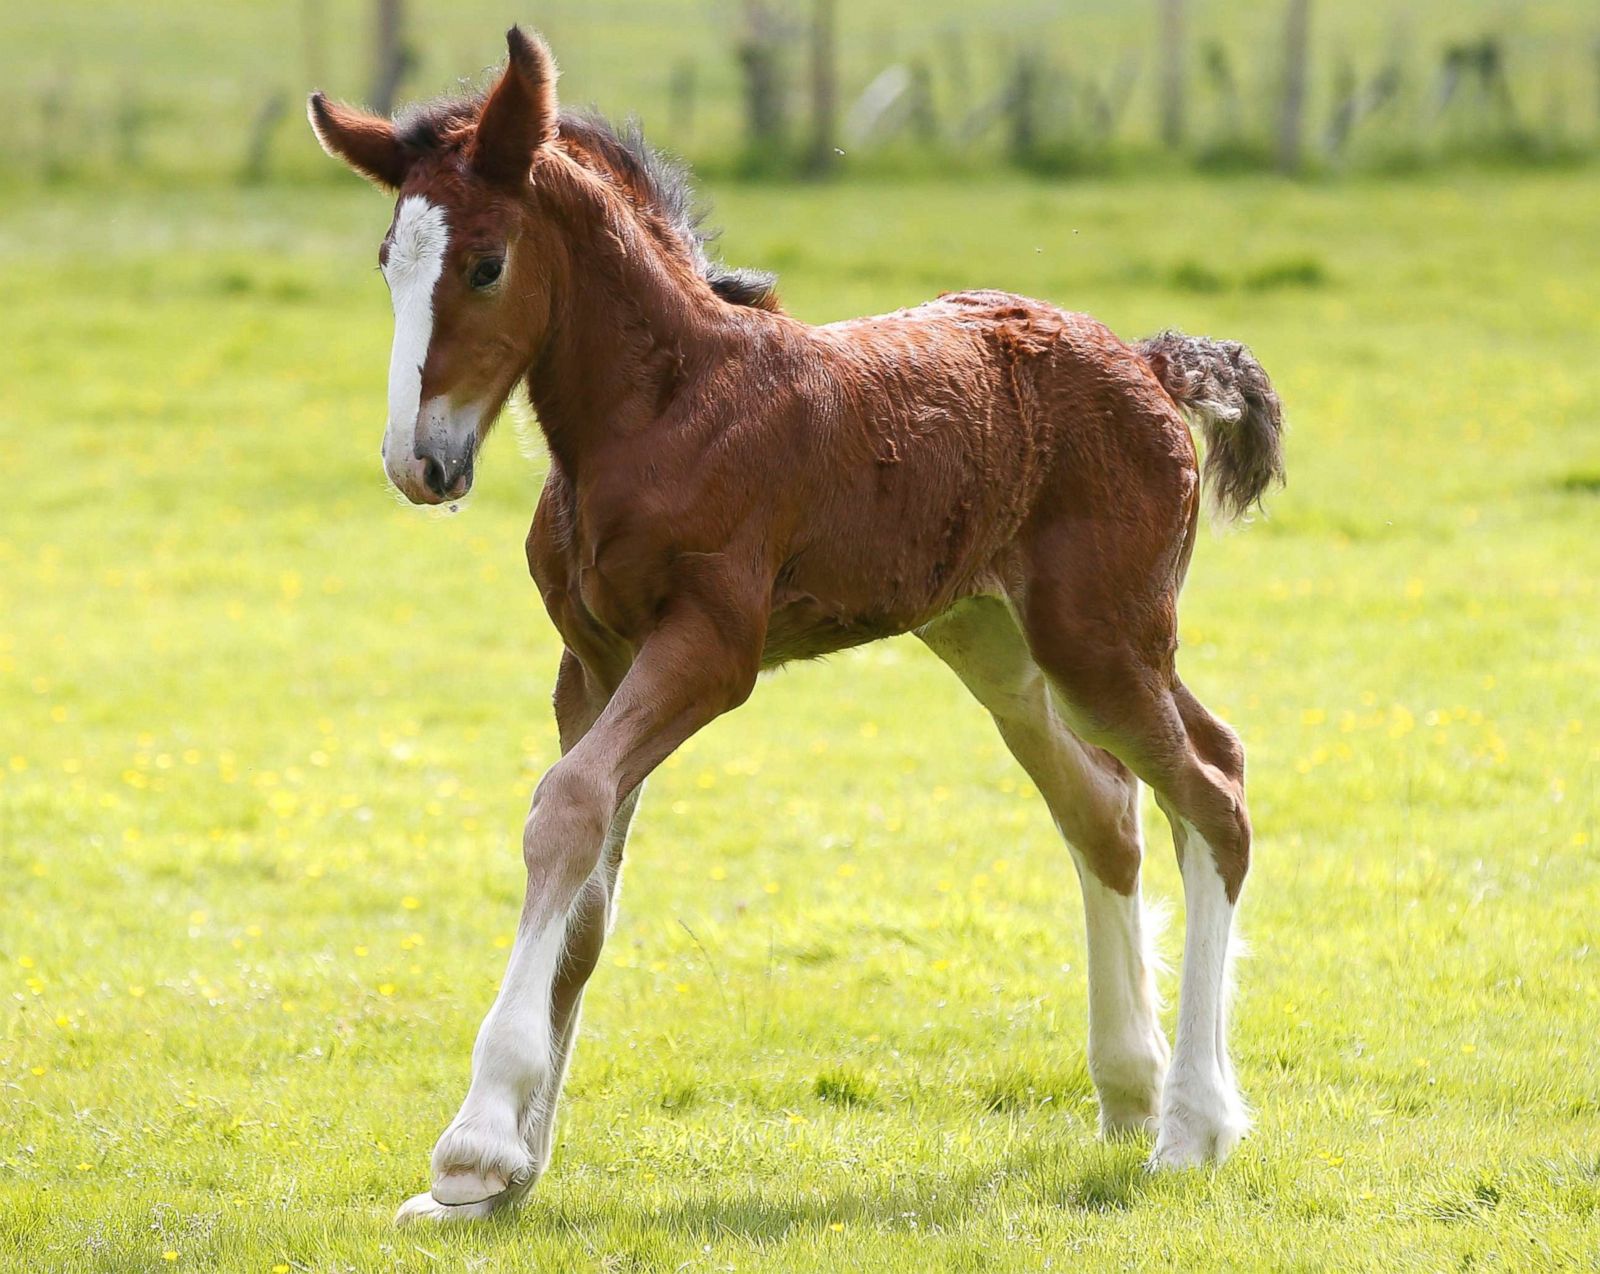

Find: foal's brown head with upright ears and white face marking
<box><xmin>309</xmin><ymin>27</ymin><xmax>558</xmax><ymax>504</ymax></box>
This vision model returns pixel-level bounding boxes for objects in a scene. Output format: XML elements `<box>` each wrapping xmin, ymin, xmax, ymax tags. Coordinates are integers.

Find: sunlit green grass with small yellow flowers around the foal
<box><xmin>0</xmin><ymin>174</ymin><xmax>1600</xmax><ymax>1271</ymax></box>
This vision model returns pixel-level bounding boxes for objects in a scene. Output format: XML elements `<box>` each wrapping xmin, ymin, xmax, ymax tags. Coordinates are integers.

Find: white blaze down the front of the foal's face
<box><xmin>384</xmin><ymin>195</ymin><xmax>450</xmax><ymax>472</ymax></box>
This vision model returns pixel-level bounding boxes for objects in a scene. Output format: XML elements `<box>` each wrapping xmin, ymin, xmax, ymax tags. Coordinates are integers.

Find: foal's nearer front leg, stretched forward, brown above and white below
<box><xmin>397</xmin><ymin>615</ymin><xmax>757</xmax><ymax>1221</ymax></box>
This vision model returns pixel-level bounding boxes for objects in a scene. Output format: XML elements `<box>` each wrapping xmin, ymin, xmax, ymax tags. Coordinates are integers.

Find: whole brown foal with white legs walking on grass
<box><xmin>310</xmin><ymin>29</ymin><xmax>1283</xmax><ymax>1220</ymax></box>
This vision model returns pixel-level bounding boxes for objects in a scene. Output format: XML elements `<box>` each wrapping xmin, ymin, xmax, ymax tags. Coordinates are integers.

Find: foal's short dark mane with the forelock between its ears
<box><xmin>395</xmin><ymin>93</ymin><xmax>778</xmax><ymax>309</ymax></box>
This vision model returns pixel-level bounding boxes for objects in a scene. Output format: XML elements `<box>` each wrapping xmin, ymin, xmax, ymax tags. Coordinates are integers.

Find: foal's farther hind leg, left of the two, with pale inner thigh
<box><xmin>920</xmin><ymin>597</ymin><xmax>1168</xmax><ymax>1136</ymax></box>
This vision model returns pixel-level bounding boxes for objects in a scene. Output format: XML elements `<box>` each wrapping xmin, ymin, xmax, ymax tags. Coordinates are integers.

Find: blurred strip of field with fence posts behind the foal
<box><xmin>9</xmin><ymin>0</ymin><xmax>1600</xmax><ymax>181</ymax></box>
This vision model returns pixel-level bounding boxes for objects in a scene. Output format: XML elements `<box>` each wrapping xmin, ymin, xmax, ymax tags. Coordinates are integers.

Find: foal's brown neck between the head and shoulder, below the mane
<box><xmin>528</xmin><ymin>186</ymin><xmax>728</xmax><ymax>471</ymax></box>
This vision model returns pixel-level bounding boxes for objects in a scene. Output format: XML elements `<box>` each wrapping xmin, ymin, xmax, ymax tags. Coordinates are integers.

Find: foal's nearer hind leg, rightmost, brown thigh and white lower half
<box><xmin>1019</xmin><ymin>563</ymin><xmax>1250</xmax><ymax>1168</ymax></box>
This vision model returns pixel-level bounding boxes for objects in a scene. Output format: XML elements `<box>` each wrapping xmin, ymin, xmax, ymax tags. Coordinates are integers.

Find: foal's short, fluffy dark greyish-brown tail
<box><xmin>1134</xmin><ymin>331</ymin><xmax>1283</xmax><ymax>522</ymax></box>
